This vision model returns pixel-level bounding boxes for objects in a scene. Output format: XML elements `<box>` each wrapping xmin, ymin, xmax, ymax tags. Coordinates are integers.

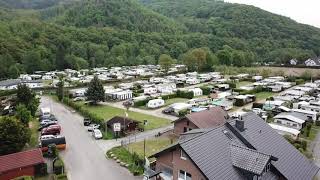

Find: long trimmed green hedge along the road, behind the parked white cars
<box><xmin>62</xmin><ymin>98</ymin><xmax>105</xmax><ymax>129</ymax></box>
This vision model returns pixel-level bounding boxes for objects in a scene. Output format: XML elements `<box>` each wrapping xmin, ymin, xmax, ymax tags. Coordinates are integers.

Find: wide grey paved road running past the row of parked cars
<box><xmin>40</xmin><ymin>97</ymin><xmax>141</xmax><ymax>180</ymax></box>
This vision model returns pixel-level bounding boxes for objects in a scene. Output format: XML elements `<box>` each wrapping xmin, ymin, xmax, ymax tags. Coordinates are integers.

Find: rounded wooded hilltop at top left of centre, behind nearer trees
<box><xmin>42</xmin><ymin>0</ymin><xmax>183</xmax><ymax>33</ymax></box>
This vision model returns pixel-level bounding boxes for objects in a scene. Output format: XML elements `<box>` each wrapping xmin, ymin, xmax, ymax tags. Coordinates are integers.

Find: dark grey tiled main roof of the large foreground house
<box><xmin>154</xmin><ymin>112</ymin><xmax>319</xmax><ymax>179</ymax></box>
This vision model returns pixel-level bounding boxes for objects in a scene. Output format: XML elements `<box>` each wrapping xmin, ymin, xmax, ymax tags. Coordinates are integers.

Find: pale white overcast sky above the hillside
<box><xmin>225</xmin><ymin>0</ymin><xmax>320</xmax><ymax>28</ymax></box>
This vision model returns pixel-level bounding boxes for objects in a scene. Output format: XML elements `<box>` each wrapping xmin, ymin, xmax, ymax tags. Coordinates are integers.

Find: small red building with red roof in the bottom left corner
<box><xmin>0</xmin><ymin>149</ymin><xmax>45</xmax><ymax>180</ymax></box>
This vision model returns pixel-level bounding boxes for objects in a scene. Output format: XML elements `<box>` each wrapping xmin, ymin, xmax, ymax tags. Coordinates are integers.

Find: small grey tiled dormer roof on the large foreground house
<box><xmin>230</xmin><ymin>144</ymin><xmax>271</xmax><ymax>175</ymax></box>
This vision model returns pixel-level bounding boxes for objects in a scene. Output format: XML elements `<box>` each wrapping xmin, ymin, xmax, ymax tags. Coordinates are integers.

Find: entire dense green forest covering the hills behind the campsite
<box><xmin>0</xmin><ymin>0</ymin><xmax>320</xmax><ymax>78</ymax></box>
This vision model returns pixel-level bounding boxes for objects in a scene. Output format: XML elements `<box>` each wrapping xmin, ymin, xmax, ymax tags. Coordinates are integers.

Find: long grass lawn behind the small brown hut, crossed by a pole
<box><xmin>79</xmin><ymin>105</ymin><xmax>171</xmax><ymax>130</ymax></box>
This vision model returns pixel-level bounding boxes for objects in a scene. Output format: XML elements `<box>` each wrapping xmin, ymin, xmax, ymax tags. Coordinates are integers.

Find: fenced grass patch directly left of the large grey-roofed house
<box><xmin>128</xmin><ymin>137</ymin><xmax>174</xmax><ymax>158</ymax></box>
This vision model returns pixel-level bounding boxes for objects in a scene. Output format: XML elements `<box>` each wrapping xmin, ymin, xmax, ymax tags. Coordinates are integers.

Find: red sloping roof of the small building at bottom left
<box><xmin>0</xmin><ymin>149</ymin><xmax>44</xmax><ymax>173</ymax></box>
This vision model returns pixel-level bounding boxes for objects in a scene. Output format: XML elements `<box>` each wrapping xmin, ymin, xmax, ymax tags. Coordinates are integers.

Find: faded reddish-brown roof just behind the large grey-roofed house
<box><xmin>178</xmin><ymin>107</ymin><xmax>228</xmax><ymax>128</ymax></box>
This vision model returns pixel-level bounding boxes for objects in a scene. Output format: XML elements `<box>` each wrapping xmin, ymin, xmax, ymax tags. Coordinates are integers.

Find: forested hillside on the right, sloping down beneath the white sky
<box><xmin>141</xmin><ymin>0</ymin><xmax>320</xmax><ymax>61</ymax></box>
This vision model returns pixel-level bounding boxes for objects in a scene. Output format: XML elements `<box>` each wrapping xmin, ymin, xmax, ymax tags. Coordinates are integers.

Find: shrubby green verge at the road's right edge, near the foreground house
<box><xmin>107</xmin><ymin>147</ymin><xmax>144</xmax><ymax>176</ymax></box>
